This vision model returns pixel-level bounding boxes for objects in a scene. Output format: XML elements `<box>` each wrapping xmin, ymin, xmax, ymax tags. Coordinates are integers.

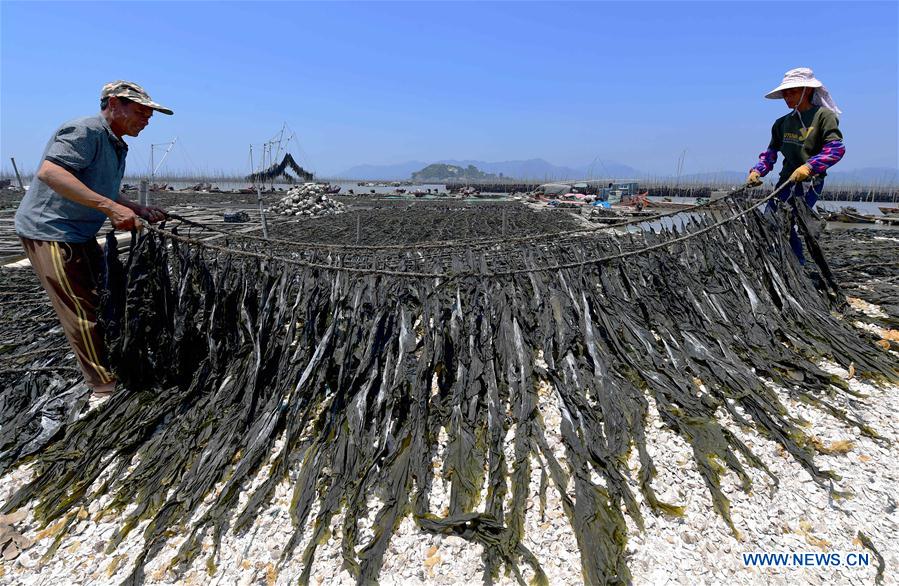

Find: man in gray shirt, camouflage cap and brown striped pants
<box><xmin>15</xmin><ymin>81</ymin><xmax>172</xmax><ymax>396</ymax></box>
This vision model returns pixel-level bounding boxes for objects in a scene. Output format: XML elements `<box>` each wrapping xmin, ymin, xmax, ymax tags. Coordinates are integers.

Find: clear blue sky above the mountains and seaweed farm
<box><xmin>0</xmin><ymin>0</ymin><xmax>899</xmax><ymax>174</ymax></box>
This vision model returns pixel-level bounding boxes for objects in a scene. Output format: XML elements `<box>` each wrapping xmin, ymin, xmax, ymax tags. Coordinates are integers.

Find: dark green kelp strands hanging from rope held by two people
<box><xmin>3</xmin><ymin>194</ymin><xmax>899</xmax><ymax>584</ymax></box>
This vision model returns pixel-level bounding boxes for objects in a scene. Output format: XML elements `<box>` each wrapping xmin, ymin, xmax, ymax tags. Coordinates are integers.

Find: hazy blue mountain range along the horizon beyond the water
<box><xmin>334</xmin><ymin>159</ymin><xmax>899</xmax><ymax>186</ymax></box>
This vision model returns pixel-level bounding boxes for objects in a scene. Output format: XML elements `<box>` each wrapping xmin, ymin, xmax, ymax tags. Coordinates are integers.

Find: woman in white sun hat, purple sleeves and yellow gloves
<box><xmin>747</xmin><ymin>67</ymin><xmax>846</xmax><ymax>264</ymax></box>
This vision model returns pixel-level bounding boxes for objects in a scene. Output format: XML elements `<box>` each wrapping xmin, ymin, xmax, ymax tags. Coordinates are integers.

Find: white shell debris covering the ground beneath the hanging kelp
<box><xmin>0</xmin><ymin>326</ymin><xmax>899</xmax><ymax>586</ymax></box>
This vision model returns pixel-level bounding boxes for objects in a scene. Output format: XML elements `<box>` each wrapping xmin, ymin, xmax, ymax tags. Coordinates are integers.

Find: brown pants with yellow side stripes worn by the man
<box><xmin>19</xmin><ymin>236</ymin><xmax>115</xmax><ymax>388</ymax></box>
